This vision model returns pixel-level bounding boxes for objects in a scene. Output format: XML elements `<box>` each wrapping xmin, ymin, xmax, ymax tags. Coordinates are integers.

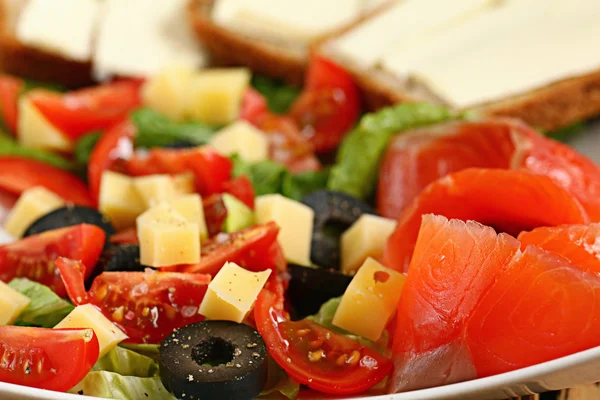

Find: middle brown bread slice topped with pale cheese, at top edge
<box><xmin>189</xmin><ymin>0</ymin><xmax>389</xmax><ymax>84</ymax></box>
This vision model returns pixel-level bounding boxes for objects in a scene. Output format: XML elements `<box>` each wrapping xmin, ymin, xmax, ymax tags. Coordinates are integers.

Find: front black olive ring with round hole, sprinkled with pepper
<box><xmin>159</xmin><ymin>321</ymin><xmax>267</xmax><ymax>400</ymax></box>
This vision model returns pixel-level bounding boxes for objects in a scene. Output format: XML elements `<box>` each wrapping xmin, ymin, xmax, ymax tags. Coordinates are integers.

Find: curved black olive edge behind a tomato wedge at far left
<box><xmin>23</xmin><ymin>205</ymin><xmax>115</xmax><ymax>241</ymax></box>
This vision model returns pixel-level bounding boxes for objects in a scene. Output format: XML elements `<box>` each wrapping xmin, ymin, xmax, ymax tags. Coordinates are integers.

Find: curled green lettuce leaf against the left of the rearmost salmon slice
<box><xmin>327</xmin><ymin>103</ymin><xmax>459</xmax><ymax>199</ymax></box>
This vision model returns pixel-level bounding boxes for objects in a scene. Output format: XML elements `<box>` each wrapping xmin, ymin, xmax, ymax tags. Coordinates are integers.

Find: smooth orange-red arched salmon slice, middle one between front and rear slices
<box><xmin>385</xmin><ymin>168</ymin><xmax>588</xmax><ymax>271</ymax></box>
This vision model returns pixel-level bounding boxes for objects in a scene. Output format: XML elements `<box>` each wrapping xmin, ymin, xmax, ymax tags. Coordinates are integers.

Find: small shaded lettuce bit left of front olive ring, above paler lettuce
<box><xmin>92</xmin><ymin>346</ymin><xmax>158</xmax><ymax>378</ymax></box>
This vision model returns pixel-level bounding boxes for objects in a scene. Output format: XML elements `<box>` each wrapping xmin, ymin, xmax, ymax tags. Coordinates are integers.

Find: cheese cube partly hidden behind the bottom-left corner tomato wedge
<box><xmin>54</xmin><ymin>304</ymin><xmax>127</xmax><ymax>358</ymax></box>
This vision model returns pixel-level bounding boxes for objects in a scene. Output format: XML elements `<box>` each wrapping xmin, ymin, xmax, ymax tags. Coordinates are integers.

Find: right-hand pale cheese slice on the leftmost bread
<box><xmin>93</xmin><ymin>0</ymin><xmax>206</xmax><ymax>79</ymax></box>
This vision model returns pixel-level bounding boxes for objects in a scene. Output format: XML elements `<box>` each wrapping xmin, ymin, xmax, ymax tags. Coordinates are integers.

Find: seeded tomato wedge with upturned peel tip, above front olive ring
<box><xmin>56</xmin><ymin>258</ymin><xmax>210</xmax><ymax>343</ymax></box>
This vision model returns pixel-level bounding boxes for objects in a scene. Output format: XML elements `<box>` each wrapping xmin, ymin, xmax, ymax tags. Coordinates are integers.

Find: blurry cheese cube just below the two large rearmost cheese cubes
<box><xmin>210</xmin><ymin>121</ymin><xmax>269</xmax><ymax>162</ymax></box>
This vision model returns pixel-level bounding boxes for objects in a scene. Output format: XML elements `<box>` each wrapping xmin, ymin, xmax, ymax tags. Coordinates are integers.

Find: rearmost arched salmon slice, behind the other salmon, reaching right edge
<box><xmin>376</xmin><ymin>119</ymin><xmax>600</xmax><ymax>221</ymax></box>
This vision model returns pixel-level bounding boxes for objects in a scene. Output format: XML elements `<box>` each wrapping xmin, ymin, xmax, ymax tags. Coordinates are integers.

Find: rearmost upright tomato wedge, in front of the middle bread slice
<box><xmin>290</xmin><ymin>57</ymin><xmax>360</xmax><ymax>153</ymax></box>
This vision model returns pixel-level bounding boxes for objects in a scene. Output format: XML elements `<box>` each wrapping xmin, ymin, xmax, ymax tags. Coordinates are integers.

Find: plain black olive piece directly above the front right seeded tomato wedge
<box><xmin>286</xmin><ymin>264</ymin><xmax>352</xmax><ymax>319</ymax></box>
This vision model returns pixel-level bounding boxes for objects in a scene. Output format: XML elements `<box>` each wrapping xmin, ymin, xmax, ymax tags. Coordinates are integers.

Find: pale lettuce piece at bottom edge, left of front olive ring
<box><xmin>69</xmin><ymin>371</ymin><xmax>175</xmax><ymax>400</ymax></box>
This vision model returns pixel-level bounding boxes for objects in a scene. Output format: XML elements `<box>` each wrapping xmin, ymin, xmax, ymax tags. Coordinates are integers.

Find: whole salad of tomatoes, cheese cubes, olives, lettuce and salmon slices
<box><xmin>0</xmin><ymin>57</ymin><xmax>600</xmax><ymax>400</ymax></box>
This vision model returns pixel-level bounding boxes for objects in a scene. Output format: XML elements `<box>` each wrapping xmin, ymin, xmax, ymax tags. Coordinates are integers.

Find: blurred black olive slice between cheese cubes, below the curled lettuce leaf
<box><xmin>302</xmin><ymin>190</ymin><xmax>375</xmax><ymax>270</ymax></box>
